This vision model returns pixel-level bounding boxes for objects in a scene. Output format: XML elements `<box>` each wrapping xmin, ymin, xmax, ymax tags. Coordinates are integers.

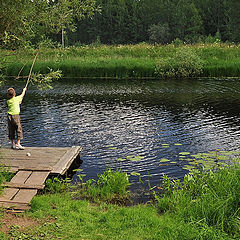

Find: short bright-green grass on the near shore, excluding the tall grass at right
<box><xmin>1</xmin><ymin>194</ymin><xmax>230</xmax><ymax>240</ymax></box>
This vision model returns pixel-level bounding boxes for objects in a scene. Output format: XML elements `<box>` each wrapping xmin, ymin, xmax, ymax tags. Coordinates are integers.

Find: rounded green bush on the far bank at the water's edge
<box><xmin>155</xmin><ymin>48</ymin><xmax>203</xmax><ymax>78</ymax></box>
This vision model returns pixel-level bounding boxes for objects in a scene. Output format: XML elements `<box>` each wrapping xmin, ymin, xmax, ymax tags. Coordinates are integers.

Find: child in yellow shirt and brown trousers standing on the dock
<box><xmin>7</xmin><ymin>88</ymin><xmax>27</xmax><ymax>150</ymax></box>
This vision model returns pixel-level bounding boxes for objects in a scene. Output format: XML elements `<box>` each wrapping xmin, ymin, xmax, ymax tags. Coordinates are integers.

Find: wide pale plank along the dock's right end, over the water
<box><xmin>52</xmin><ymin>146</ymin><xmax>82</xmax><ymax>175</ymax></box>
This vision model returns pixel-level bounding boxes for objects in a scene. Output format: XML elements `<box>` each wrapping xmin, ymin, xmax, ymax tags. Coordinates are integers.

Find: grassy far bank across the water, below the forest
<box><xmin>0</xmin><ymin>44</ymin><xmax>240</xmax><ymax>78</ymax></box>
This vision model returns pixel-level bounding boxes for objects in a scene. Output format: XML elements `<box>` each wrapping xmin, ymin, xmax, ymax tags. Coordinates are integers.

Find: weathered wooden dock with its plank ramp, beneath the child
<box><xmin>0</xmin><ymin>146</ymin><xmax>82</xmax><ymax>211</ymax></box>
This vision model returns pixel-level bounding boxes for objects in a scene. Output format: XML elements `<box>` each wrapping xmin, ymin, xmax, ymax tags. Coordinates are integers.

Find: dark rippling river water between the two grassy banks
<box><xmin>0</xmin><ymin>80</ymin><xmax>240</xmax><ymax>190</ymax></box>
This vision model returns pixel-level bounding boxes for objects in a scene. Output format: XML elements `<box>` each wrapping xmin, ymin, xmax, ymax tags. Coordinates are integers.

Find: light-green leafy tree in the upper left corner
<box><xmin>0</xmin><ymin>0</ymin><xmax>99</xmax><ymax>48</ymax></box>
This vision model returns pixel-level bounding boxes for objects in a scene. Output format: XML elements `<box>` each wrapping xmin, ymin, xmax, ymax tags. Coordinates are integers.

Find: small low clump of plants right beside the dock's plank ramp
<box><xmin>43</xmin><ymin>177</ymin><xmax>69</xmax><ymax>193</ymax></box>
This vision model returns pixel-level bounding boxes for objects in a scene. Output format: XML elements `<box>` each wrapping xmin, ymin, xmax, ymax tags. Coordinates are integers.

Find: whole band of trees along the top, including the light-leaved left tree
<box><xmin>0</xmin><ymin>0</ymin><xmax>240</xmax><ymax>48</ymax></box>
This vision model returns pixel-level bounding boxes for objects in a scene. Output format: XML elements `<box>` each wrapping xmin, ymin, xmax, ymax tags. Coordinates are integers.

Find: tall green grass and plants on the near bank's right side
<box><xmin>155</xmin><ymin>164</ymin><xmax>240</xmax><ymax>239</ymax></box>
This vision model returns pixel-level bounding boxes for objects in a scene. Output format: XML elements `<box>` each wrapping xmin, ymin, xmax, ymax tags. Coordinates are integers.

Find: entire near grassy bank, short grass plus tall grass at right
<box><xmin>0</xmin><ymin>164</ymin><xmax>240</xmax><ymax>240</ymax></box>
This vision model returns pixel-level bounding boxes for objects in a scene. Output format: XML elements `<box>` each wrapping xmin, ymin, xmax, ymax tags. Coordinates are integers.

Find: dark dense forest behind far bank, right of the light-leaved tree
<box><xmin>75</xmin><ymin>0</ymin><xmax>240</xmax><ymax>44</ymax></box>
